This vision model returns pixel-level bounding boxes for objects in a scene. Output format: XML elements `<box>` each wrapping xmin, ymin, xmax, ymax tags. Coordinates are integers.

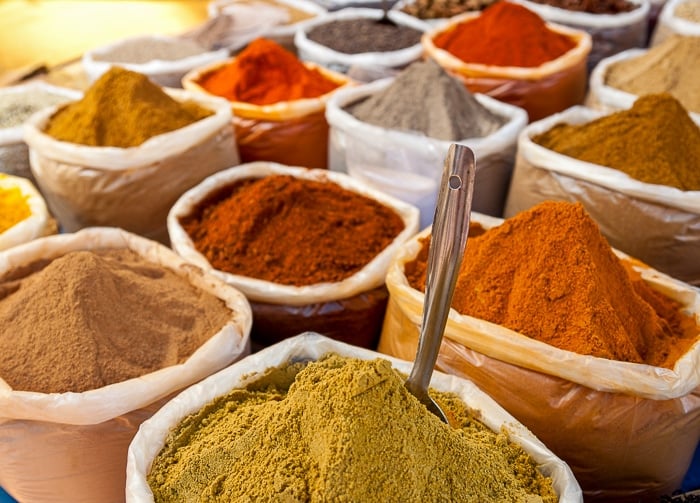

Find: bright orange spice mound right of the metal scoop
<box><xmin>405</xmin><ymin>202</ymin><xmax>698</xmax><ymax>368</ymax></box>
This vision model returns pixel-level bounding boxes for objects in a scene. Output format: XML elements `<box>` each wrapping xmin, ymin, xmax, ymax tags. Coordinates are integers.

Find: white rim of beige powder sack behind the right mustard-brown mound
<box><xmin>586</xmin><ymin>49</ymin><xmax>700</xmax><ymax>124</ymax></box>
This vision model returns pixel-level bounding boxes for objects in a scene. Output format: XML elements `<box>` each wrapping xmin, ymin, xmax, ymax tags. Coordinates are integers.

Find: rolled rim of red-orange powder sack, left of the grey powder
<box><xmin>182</xmin><ymin>57</ymin><xmax>355</xmax><ymax>120</ymax></box>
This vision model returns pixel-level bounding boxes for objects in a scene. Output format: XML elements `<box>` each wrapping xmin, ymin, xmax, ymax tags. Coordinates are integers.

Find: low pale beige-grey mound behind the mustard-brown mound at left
<box><xmin>93</xmin><ymin>37</ymin><xmax>207</xmax><ymax>64</ymax></box>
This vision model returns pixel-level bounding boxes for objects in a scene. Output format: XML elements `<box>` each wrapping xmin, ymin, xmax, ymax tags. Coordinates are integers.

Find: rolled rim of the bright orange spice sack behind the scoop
<box><xmin>386</xmin><ymin>221</ymin><xmax>700</xmax><ymax>400</ymax></box>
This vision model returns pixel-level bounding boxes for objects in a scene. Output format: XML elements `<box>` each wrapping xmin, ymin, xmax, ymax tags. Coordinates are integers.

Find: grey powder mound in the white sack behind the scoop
<box><xmin>346</xmin><ymin>60</ymin><xmax>506</xmax><ymax>141</ymax></box>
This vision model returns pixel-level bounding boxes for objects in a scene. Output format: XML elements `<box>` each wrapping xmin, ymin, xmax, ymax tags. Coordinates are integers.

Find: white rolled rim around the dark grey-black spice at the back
<box><xmin>294</xmin><ymin>7</ymin><xmax>430</xmax><ymax>73</ymax></box>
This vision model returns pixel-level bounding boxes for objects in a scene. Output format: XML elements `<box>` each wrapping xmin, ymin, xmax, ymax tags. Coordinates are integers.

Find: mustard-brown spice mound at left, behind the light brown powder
<box><xmin>44</xmin><ymin>66</ymin><xmax>213</xmax><ymax>148</ymax></box>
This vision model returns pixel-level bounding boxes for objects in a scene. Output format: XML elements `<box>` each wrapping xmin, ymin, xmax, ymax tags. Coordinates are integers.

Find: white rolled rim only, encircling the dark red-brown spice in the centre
<box><xmin>168</xmin><ymin>162</ymin><xmax>418</xmax><ymax>306</ymax></box>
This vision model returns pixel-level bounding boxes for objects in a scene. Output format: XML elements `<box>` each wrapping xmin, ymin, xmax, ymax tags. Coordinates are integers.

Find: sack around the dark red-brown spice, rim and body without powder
<box><xmin>168</xmin><ymin>162</ymin><xmax>418</xmax><ymax>348</ymax></box>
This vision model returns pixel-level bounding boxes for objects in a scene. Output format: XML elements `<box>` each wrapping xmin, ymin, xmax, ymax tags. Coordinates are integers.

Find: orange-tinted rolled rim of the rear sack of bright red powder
<box><xmin>421</xmin><ymin>12</ymin><xmax>593</xmax><ymax>80</ymax></box>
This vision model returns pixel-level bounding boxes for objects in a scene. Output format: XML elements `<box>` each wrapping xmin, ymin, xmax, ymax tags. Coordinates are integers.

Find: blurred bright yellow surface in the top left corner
<box><xmin>0</xmin><ymin>0</ymin><xmax>209</xmax><ymax>75</ymax></box>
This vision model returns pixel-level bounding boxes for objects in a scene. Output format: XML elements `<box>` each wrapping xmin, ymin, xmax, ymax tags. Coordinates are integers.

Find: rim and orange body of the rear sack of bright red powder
<box><xmin>421</xmin><ymin>12</ymin><xmax>591</xmax><ymax>121</ymax></box>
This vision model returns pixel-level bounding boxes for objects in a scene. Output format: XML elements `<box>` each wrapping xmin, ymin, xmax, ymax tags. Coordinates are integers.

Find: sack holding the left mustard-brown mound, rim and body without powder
<box><xmin>24</xmin><ymin>89</ymin><xmax>239</xmax><ymax>241</ymax></box>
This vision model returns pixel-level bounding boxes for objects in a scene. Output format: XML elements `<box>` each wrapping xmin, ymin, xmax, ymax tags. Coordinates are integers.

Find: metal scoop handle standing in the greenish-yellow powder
<box><xmin>405</xmin><ymin>144</ymin><xmax>476</xmax><ymax>423</ymax></box>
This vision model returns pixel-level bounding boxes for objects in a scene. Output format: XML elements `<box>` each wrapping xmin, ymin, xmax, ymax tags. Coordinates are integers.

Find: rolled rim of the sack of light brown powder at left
<box><xmin>0</xmin><ymin>227</ymin><xmax>252</xmax><ymax>425</ymax></box>
